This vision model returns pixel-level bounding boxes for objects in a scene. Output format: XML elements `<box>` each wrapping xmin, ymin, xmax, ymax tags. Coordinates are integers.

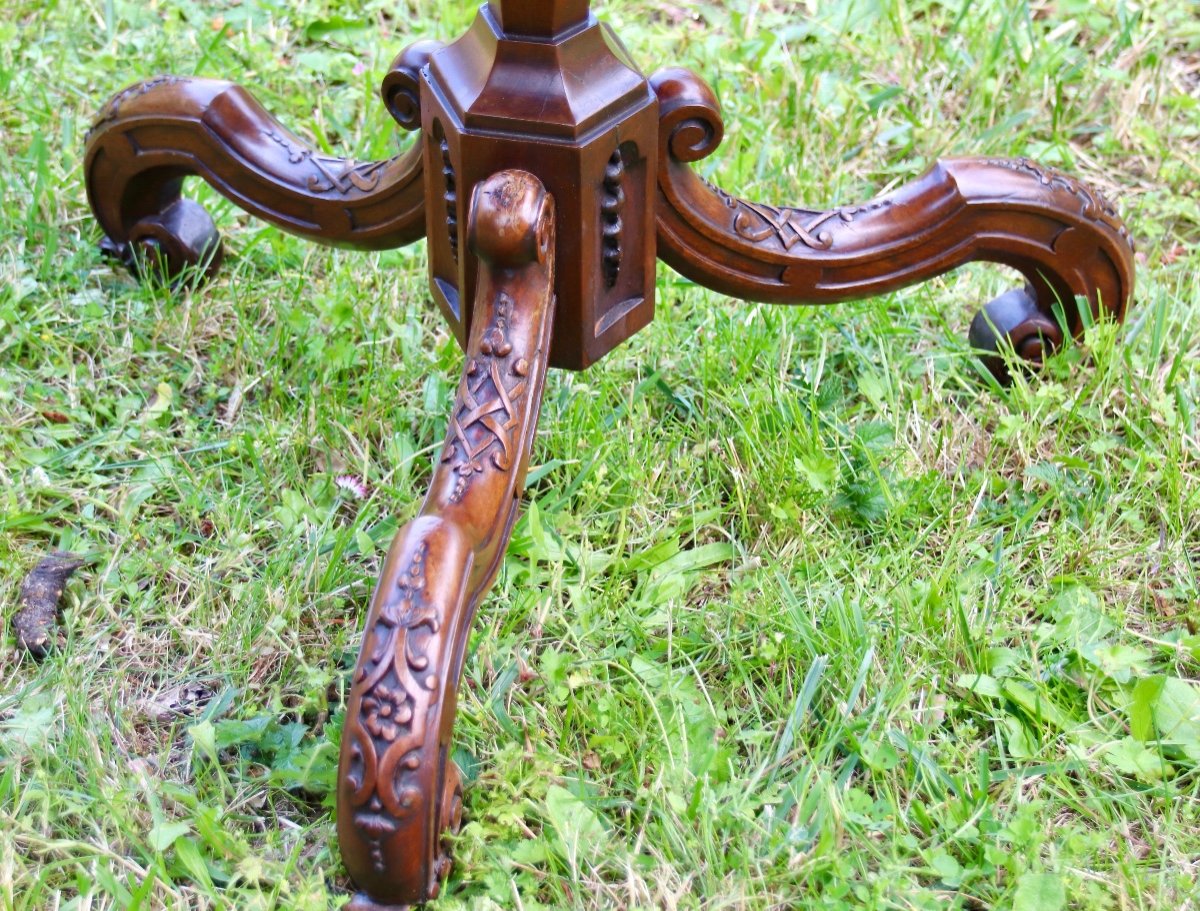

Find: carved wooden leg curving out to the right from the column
<box><xmin>650</xmin><ymin>70</ymin><xmax>1134</xmax><ymax>378</ymax></box>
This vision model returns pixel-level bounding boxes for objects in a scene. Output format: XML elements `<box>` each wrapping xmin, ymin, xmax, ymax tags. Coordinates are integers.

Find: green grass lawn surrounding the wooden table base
<box><xmin>0</xmin><ymin>0</ymin><xmax>1200</xmax><ymax>911</ymax></box>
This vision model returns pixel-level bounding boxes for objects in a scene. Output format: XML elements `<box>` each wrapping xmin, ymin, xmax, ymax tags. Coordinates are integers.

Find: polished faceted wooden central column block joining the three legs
<box><xmin>420</xmin><ymin>4</ymin><xmax>659</xmax><ymax>370</ymax></box>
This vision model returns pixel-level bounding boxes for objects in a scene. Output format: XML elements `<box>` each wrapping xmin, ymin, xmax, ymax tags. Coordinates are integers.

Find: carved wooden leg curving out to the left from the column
<box><xmin>84</xmin><ymin>42</ymin><xmax>438</xmax><ymax>278</ymax></box>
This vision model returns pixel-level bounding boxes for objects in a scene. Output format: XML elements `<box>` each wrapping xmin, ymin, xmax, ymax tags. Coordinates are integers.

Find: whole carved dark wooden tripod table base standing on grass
<box><xmin>85</xmin><ymin>0</ymin><xmax>1134</xmax><ymax>911</ymax></box>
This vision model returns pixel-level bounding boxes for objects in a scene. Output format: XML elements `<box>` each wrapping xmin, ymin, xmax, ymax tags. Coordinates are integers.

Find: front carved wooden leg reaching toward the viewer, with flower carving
<box><xmin>337</xmin><ymin>170</ymin><xmax>554</xmax><ymax>911</ymax></box>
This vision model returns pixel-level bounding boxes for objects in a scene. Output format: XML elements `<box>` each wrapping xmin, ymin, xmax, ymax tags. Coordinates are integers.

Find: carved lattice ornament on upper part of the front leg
<box><xmin>442</xmin><ymin>293</ymin><xmax>529</xmax><ymax>503</ymax></box>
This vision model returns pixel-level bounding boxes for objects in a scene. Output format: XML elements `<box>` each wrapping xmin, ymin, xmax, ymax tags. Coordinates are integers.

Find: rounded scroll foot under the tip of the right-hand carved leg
<box><xmin>967</xmin><ymin>284</ymin><xmax>1062</xmax><ymax>385</ymax></box>
